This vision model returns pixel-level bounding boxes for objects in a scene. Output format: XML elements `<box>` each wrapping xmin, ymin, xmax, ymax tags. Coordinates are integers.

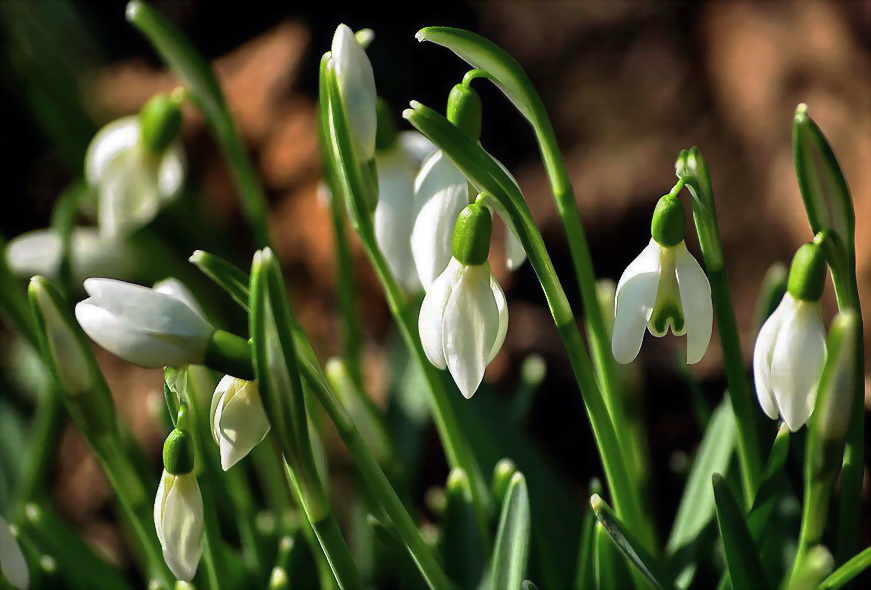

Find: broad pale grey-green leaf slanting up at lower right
<box><xmin>666</xmin><ymin>399</ymin><xmax>736</xmax><ymax>588</ymax></box>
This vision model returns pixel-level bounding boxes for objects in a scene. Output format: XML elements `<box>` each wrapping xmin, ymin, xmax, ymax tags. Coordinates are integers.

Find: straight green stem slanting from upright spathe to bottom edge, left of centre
<box><xmin>211</xmin><ymin>332</ymin><xmax>451</xmax><ymax>588</ymax></box>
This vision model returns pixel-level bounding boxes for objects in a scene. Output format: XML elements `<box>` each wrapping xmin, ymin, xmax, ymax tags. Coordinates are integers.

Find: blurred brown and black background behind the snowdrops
<box><xmin>0</xmin><ymin>0</ymin><xmax>871</xmax><ymax>580</ymax></box>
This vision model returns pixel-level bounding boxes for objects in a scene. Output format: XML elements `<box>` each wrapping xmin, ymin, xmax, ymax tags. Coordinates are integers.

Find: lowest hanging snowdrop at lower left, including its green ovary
<box><xmin>154</xmin><ymin>424</ymin><xmax>205</xmax><ymax>582</ymax></box>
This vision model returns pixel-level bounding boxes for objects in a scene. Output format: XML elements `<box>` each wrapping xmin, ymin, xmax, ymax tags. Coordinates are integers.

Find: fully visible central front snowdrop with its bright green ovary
<box><xmin>418</xmin><ymin>204</ymin><xmax>508</xmax><ymax>398</ymax></box>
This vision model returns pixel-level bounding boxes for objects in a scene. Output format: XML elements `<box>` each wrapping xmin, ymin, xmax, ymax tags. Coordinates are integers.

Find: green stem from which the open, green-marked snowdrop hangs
<box><xmin>675</xmin><ymin>148</ymin><xmax>762</xmax><ymax>507</ymax></box>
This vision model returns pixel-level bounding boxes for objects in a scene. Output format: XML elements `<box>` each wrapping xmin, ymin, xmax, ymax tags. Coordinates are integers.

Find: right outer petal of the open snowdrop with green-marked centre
<box><xmin>675</xmin><ymin>242</ymin><xmax>714</xmax><ymax>365</ymax></box>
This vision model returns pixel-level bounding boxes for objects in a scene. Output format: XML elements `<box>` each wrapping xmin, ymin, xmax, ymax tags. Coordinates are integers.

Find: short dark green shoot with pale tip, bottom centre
<box><xmin>439</xmin><ymin>469</ymin><xmax>487</xmax><ymax>589</ymax></box>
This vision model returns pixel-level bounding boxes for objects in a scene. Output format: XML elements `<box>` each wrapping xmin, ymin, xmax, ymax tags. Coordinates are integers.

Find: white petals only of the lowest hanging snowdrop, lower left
<box><xmin>154</xmin><ymin>470</ymin><xmax>205</xmax><ymax>582</ymax></box>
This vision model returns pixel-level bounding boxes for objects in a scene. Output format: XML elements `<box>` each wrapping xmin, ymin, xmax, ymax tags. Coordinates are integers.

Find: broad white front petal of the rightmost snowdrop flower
<box><xmin>771</xmin><ymin>301</ymin><xmax>826</xmax><ymax>432</ymax></box>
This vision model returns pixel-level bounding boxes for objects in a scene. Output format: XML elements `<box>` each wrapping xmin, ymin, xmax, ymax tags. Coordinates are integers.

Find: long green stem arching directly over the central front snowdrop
<box><xmin>403</xmin><ymin>103</ymin><xmax>655</xmax><ymax>551</ymax></box>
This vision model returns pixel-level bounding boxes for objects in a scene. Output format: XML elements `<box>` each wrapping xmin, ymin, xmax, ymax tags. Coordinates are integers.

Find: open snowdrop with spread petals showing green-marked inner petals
<box><xmin>611</xmin><ymin>195</ymin><xmax>714</xmax><ymax>364</ymax></box>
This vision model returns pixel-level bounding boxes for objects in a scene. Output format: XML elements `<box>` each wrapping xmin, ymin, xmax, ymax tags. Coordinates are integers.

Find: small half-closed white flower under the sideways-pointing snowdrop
<box><xmin>211</xmin><ymin>375</ymin><xmax>270</xmax><ymax>471</ymax></box>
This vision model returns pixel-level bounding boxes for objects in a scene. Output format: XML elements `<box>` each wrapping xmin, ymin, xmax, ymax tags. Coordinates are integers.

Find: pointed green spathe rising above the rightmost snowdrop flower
<box><xmin>792</xmin><ymin>104</ymin><xmax>856</xmax><ymax>257</ymax></box>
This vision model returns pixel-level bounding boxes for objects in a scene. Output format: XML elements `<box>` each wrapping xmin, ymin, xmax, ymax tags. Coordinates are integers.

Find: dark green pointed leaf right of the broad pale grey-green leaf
<box><xmin>711</xmin><ymin>473</ymin><xmax>766</xmax><ymax>589</ymax></box>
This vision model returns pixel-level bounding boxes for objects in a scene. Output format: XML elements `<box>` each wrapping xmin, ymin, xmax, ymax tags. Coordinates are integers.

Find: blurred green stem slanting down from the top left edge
<box><xmin>127</xmin><ymin>0</ymin><xmax>270</xmax><ymax>247</ymax></box>
